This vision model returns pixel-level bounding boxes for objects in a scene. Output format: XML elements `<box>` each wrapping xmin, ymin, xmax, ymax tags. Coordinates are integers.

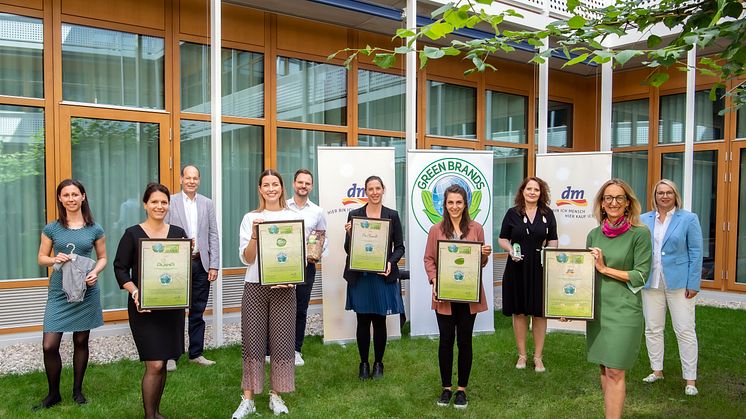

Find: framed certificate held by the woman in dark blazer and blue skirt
<box><xmin>350</xmin><ymin>217</ymin><xmax>391</xmax><ymax>273</ymax></box>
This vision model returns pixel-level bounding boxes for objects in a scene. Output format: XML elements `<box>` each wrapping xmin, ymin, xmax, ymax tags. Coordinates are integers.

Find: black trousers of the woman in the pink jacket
<box><xmin>436</xmin><ymin>303</ymin><xmax>477</xmax><ymax>387</ymax></box>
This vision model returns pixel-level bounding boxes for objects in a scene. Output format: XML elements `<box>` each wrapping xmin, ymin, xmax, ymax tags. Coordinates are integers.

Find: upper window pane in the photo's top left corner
<box><xmin>0</xmin><ymin>13</ymin><xmax>44</xmax><ymax>98</ymax></box>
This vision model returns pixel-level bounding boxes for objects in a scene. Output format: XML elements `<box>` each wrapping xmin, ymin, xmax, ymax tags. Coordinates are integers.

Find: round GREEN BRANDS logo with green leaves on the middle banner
<box><xmin>410</xmin><ymin>157</ymin><xmax>492</xmax><ymax>233</ymax></box>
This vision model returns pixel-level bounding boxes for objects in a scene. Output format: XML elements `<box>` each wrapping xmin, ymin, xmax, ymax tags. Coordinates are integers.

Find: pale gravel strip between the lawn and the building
<box><xmin>0</xmin><ymin>293</ymin><xmax>746</xmax><ymax>376</ymax></box>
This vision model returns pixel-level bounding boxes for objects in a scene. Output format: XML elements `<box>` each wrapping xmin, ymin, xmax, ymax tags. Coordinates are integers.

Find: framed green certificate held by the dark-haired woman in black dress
<box><xmin>139</xmin><ymin>239</ymin><xmax>192</xmax><ymax>310</ymax></box>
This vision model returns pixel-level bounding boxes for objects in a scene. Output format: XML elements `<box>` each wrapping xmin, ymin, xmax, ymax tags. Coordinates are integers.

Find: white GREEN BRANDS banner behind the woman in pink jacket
<box><xmin>407</xmin><ymin>150</ymin><xmax>495</xmax><ymax>336</ymax></box>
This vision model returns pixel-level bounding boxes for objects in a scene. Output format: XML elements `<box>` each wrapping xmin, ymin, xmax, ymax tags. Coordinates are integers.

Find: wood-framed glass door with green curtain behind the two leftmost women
<box><xmin>60</xmin><ymin>106</ymin><xmax>173</xmax><ymax>309</ymax></box>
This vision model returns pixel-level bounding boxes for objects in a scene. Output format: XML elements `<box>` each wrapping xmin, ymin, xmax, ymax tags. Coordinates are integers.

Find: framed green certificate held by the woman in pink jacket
<box><xmin>435</xmin><ymin>240</ymin><xmax>482</xmax><ymax>303</ymax></box>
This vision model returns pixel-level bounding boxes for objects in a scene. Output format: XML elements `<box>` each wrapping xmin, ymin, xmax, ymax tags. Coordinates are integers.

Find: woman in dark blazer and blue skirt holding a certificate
<box><xmin>343</xmin><ymin>176</ymin><xmax>404</xmax><ymax>380</ymax></box>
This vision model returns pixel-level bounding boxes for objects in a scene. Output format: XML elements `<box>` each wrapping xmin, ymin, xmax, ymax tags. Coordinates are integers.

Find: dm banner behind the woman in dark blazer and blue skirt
<box><xmin>318</xmin><ymin>147</ymin><xmax>403</xmax><ymax>343</ymax></box>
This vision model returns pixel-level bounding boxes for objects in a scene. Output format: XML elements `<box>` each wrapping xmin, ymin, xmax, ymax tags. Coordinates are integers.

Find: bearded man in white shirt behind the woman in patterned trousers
<box><xmin>287</xmin><ymin>169</ymin><xmax>326</xmax><ymax>365</ymax></box>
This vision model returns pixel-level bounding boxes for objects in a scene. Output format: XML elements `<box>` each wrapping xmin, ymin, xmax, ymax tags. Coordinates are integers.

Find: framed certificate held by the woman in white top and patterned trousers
<box><xmin>256</xmin><ymin>220</ymin><xmax>306</xmax><ymax>285</ymax></box>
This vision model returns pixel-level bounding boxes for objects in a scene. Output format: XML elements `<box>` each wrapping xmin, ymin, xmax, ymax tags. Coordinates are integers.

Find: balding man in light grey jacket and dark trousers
<box><xmin>166</xmin><ymin>165</ymin><xmax>220</xmax><ymax>371</ymax></box>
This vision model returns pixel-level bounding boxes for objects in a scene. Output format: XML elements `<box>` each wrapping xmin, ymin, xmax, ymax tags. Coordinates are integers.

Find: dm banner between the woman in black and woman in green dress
<box><xmin>536</xmin><ymin>152</ymin><xmax>611</xmax><ymax>333</ymax></box>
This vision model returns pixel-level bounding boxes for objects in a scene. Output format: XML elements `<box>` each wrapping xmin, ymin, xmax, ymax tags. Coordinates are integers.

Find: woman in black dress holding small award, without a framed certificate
<box><xmin>499</xmin><ymin>177</ymin><xmax>557</xmax><ymax>372</ymax></box>
